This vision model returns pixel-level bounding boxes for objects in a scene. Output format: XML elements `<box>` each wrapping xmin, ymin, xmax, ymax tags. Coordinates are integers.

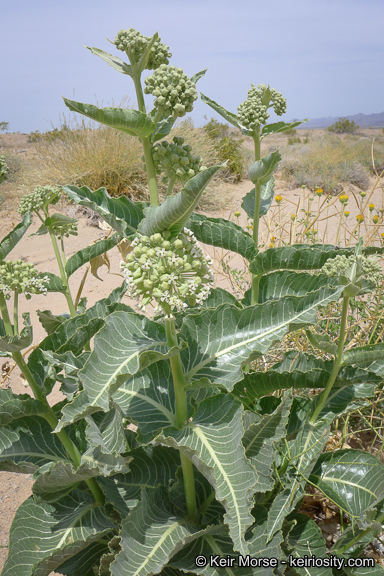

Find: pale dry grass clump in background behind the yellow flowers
<box><xmin>280</xmin><ymin>134</ymin><xmax>384</xmax><ymax>194</ymax></box>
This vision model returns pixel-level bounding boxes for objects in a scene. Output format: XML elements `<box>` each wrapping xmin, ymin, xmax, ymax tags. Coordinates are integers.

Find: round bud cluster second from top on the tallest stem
<box><xmin>144</xmin><ymin>64</ymin><xmax>197</xmax><ymax>118</ymax></box>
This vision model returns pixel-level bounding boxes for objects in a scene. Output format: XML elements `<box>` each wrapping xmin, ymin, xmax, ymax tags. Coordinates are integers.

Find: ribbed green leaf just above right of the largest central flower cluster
<box><xmin>187</xmin><ymin>213</ymin><xmax>257</xmax><ymax>260</ymax></box>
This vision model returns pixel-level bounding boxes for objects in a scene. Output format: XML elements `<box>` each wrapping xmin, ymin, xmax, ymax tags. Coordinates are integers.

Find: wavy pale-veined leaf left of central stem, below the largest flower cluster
<box><xmin>57</xmin><ymin>311</ymin><xmax>179</xmax><ymax>430</ymax></box>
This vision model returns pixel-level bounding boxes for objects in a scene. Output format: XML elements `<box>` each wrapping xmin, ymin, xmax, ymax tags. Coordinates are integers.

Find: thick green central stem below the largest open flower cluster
<box><xmin>165</xmin><ymin>316</ymin><xmax>198</xmax><ymax>521</ymax></box>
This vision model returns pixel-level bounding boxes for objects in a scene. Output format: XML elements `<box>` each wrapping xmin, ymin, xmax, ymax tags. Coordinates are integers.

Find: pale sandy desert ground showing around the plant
<box><xmin>0</xmin><ymin>133</ymin><xmax>384</xmax><ymax>576</ymax></box>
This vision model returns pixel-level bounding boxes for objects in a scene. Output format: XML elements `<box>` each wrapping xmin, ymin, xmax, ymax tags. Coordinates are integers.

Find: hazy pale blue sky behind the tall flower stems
<box><xmin>0</xmin><ymin>0</ymin><xmax>384</xmax><ymax>132</ymax></box>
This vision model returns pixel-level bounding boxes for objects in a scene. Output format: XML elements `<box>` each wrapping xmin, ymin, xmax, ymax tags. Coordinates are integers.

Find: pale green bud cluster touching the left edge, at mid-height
<box><xmin>0</xmin><ymin>260</ymin><xmax>49</xmax><ymax>298</ymax></box>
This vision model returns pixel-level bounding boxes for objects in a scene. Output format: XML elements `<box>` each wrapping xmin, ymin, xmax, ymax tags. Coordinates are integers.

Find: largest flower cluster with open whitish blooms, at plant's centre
<box><xmin>121</xmin><ymin>228</ymin><xmax>213</xmax><ymax>315</ymax></box>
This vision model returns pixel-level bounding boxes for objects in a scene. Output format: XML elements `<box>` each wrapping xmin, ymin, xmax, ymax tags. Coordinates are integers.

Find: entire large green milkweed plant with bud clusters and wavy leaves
<box><xmin>0</xmin><ymin>28</ymin><xmax>384</xmax><ymax>576</ymax></box>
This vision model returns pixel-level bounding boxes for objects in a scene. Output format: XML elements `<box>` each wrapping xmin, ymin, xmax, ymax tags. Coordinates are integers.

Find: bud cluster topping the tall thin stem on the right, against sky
<box><xmin>237</xmin><ymin>84</ymin><xmax>287</xmax><ymax>130</ymax></box>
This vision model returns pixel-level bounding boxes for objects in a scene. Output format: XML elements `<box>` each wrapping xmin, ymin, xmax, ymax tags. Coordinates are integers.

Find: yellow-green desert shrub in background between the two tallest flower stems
<box><xmin>204</xmin><ymin>118</ymin><xmax>245</xmax><ymax>182</ymax></box>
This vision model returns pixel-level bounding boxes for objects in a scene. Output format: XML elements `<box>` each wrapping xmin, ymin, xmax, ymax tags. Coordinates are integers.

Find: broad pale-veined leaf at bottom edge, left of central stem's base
<box><xmin>111</xmin><ymin>487</ymin><xmax>201</xmax><ymax>576</ymax></box>
